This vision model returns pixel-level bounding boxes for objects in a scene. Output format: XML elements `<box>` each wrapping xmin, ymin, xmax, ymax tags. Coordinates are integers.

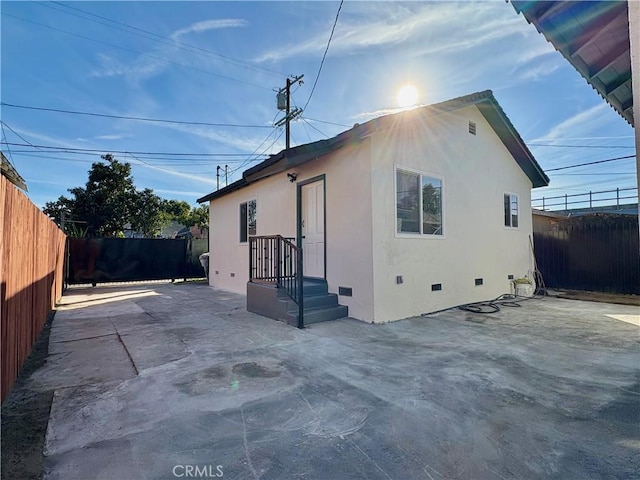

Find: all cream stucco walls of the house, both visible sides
<box><xmin>210</xmin><ymin>106</ymin><xmax>532</xmax><ymax>322</ymax></box>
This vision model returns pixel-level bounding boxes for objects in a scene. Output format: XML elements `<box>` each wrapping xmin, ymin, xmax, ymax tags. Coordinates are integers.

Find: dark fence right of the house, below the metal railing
<box><xmin>533</xmin><ymin>214</ymin><xmax>640</xmax><ymax>295</ymax></box>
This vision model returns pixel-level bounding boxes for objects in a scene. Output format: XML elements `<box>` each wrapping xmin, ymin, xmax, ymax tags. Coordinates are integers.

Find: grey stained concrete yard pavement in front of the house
<box><xmin>17</xmin><ymin>283</ymin><xmax>640</xmax><ymax>480</ymax></box>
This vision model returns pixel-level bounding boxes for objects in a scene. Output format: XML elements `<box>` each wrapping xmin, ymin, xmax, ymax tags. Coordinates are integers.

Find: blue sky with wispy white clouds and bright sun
<box><xmin>0</xmin><ymin>0</ymin><xmax>636</xmax><ymax>210</ymax></box>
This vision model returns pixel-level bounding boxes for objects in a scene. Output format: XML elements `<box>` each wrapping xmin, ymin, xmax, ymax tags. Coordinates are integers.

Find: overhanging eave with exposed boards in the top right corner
<box><xmin>511</xmin><ymin>0</ymin><xmax>633</xmax><ymax>126</ymax></box>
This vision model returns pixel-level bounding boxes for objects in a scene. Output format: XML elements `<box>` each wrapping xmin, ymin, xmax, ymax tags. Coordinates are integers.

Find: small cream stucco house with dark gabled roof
<box><xmin>198</xmin><ymin>91</ymin><xmax>549</xmax><ymax>322</ymax></box>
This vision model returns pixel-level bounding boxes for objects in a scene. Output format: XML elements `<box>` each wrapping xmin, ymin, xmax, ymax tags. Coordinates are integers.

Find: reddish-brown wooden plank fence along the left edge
<box><xmin>0</xmin><ymin>177</ymin><xmax>66</xmax><ymax>401</ymax></box>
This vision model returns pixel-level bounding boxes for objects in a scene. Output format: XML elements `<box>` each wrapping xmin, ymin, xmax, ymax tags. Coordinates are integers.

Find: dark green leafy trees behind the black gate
<box><xmin>43</xmin><ymin>154</ymin><xmax>209</xmax><ymax>237</ymax></box>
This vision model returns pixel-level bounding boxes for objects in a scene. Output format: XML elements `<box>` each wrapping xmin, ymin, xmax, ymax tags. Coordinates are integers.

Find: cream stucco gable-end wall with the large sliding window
<box><xmin>371</xmin><ymin>106</ymin><xmax>532</xmax><ymax>322</ymax></box>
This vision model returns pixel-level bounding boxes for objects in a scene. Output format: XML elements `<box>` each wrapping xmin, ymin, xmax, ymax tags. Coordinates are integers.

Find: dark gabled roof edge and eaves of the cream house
<box><xmin>198</xmin><ymin>90</ymin><xmax>549</xmax><ymax>203</ymax></box>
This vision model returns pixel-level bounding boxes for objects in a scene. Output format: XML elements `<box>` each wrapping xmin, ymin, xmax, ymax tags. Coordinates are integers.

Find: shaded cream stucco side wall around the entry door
<box><xmin>209</xmin><ymin>139</ymin><xmax>374</xmax><ymax>321</ymax></box>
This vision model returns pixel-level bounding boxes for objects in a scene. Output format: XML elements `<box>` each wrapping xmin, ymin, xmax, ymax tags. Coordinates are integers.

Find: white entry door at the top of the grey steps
<box><xmin>301</xmin><ymin>180</ymin><xmax>324</xmax><ymax>278</ymax></box>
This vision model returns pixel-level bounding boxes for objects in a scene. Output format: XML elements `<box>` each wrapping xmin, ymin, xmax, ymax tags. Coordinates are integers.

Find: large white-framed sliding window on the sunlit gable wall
<box><xmin>396</xmin><ymin>168</ymin><xmax>443</xmax><ymax>235</ymax></box>
